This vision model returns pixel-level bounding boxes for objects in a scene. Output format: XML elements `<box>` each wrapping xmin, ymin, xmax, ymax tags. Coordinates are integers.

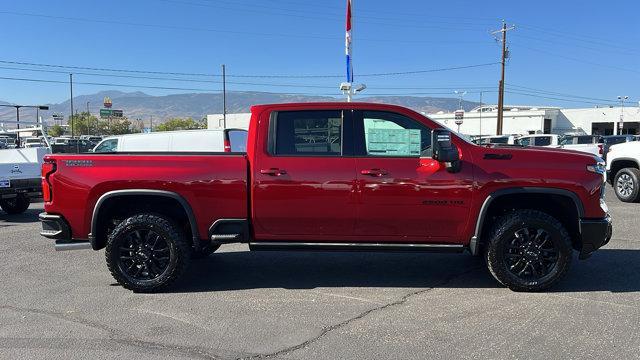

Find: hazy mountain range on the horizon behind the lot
<box><xmin>0</xmin><ymin>90</ymin><xmax>479</xmax><ymax>122</ymax></box>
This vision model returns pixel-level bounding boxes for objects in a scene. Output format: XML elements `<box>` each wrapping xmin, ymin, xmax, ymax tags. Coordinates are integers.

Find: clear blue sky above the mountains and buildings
<box><xmin>0</xmin><ymin>0</ymin><xmax>640</xmax><ymax>107</ymax></box>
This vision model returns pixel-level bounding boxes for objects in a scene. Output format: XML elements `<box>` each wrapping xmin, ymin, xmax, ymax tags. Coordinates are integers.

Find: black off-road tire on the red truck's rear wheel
<box><xmin>105</xmin><ymin>213</ymin><xmax>192</xmax><ymax>293</ymax></box>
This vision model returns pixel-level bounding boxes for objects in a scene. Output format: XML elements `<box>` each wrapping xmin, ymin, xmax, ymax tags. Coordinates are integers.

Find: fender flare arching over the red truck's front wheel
<box><xmin>469</xmin><ymin>187</ymin><xmax>584</xmax><ymax>255</ymax></box>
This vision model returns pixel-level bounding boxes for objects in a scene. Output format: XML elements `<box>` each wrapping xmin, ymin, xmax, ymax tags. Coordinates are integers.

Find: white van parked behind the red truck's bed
<box><xmin>93</xmin><ymin>129</ymin><xmax>247</xmax><ymax>153</ymax></box>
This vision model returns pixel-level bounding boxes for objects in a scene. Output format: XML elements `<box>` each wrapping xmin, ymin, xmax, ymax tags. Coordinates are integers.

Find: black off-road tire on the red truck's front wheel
<box><xmin>485</xmin><ymin>210</ymin><xmax>573</xmax><ymax>291</ymax></box>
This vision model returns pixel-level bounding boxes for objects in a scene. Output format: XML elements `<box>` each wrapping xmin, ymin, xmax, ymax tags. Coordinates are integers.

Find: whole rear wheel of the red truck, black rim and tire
<box><xmin>105</xmin><ymin>214</ymin><xmax>191</xmax><ymax>292</ymax></box>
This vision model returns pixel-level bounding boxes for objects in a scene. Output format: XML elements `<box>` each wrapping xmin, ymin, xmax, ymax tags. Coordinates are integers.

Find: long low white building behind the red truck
<box><xmin>207</xmin><ymin>105</ymin><xmax>640</xmax><ymax>136</ymax></box>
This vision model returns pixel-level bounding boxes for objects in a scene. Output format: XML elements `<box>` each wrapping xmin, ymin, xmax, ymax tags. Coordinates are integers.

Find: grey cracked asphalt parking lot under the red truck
<box><xmin>0</xmin><ymin>189</ymin><xmax>640</xmax><ymax>359</ymax></box>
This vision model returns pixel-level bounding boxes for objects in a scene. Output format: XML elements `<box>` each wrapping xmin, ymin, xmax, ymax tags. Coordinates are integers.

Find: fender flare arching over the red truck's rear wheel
<box><xmin>89</xmin><ymin>189</ymin><xmax>201</xmax><ymax>250</ymax></box>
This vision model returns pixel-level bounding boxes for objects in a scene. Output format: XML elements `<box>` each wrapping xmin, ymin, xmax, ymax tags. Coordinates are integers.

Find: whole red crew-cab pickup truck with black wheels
<box><xmin>40</xmin><ymin>103</ymin><xmax>612</xmax><ymax>292</ymax></box>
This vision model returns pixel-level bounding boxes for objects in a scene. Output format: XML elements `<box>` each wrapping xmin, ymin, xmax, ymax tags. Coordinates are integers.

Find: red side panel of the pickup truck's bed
<box><xmin>45</xmin><ymin>153</ymin><xmax>248</xmax><ymax>239</ymax></box>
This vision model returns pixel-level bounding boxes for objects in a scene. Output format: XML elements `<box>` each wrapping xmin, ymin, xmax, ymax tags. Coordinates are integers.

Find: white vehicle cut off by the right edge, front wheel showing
<box><xmin>607</xmin><ymin>141</ymin><xmax>640</xmax><ymax>202</ymax></box>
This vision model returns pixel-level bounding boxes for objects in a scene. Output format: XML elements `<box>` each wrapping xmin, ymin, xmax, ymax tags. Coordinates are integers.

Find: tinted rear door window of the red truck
<box><xmin>270</xmin><ymin>110</ymin><xmax>344</xmax><ymax>156</ymax></box>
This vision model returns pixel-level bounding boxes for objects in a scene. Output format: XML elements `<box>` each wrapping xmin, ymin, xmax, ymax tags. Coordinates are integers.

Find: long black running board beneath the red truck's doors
<box><xmin>249</xmin><ymin>241</ymin><xmax>465</xmax><ymax>252</ymax></box>
